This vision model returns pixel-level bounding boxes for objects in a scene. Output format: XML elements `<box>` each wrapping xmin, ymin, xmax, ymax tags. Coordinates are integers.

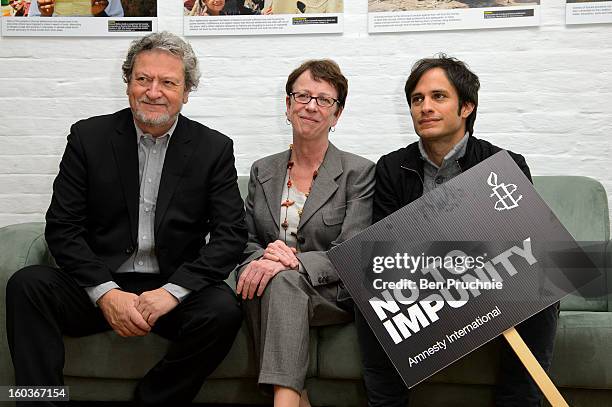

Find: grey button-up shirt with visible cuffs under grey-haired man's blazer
<box><xmin>85</xmin><ymin>120</ymin><xmax>191</xmax><ymax>304</ymax></box>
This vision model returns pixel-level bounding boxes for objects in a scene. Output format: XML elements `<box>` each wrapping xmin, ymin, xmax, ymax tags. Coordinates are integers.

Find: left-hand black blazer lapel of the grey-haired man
<box><xmin>111</xmin><ymin>109</ymin><xmax>140</xmax><ymax>242</ymax></box>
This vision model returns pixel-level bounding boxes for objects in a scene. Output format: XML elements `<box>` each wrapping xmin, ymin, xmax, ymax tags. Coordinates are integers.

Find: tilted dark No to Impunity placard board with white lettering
<box><xmin>328</xmin><ymin>152</ymin><xmax>599</xmax><ymax>387</ymax></box>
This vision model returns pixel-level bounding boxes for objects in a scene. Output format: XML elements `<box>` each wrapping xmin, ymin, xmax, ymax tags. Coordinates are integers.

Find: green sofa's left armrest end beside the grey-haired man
<box><xmin>0</xmin><ymin>222</ymin><xmax>55</xmax><ymax>385</ymax></box>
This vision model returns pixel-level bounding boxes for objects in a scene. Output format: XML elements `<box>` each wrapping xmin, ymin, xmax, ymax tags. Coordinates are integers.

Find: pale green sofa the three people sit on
<box><xmin>0</xmin><ymin>176</ymin><xmax>612</xmax><ymax>407</ymax></box>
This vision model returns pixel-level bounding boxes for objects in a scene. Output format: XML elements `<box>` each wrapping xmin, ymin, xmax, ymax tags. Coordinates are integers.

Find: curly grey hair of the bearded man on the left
<box><xmin>121</xmin><ymin>31</ymin><xmax>200</xmax><ymax>92</ymax></box>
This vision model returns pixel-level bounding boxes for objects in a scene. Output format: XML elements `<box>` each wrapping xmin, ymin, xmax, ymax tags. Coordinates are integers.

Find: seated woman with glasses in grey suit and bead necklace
<box><xmin>237</xmin><ymin>60</ymin><xmax>374</xmax><ymax>407</ymax></box>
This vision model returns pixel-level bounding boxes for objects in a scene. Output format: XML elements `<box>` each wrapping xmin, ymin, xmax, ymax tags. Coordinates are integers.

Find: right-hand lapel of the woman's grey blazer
<box><xmin>298</xmin><ymin>143</ymin><xmax>342</xmax><ymax>230</ymax></box>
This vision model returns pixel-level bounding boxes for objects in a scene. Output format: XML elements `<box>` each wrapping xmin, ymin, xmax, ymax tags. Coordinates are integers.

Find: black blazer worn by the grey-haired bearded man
<box><xmin>45</xmin><ymin>109</ymin><xmax>247</xmax><ymax>290</ymax></box>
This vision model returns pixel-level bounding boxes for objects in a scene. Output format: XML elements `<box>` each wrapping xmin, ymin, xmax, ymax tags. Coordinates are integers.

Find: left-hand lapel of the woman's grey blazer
<box><xmin>257</xmin><ymin>150</ymin><xmax>291</xmax><ymax>233</ymax></box>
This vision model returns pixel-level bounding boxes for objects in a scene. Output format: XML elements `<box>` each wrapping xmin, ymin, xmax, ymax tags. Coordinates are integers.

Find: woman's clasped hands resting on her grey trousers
<box><xmin>236</xmin><ymin>240</ymin><xmax>300</xmax><ymax>300</ymax></box>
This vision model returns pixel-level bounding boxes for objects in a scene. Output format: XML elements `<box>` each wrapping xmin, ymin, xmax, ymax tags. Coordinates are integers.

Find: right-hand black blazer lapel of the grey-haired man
<box><xmin>155</xmin><ymin>115</ymin><xmax>195</xmax><ymax>234</ymax></box>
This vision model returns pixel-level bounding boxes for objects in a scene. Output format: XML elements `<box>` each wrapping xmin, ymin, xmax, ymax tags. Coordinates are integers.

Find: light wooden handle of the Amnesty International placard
<box><xmin>504</xmin><ymin>327</ymin><xmax>569</xmax><ymax>407</ymax></box>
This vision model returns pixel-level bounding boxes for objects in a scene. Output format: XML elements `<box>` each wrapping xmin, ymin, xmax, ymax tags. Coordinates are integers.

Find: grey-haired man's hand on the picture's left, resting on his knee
<box><xmin>98</xmin><ymin>288</ymin><xmax>151</xmax><ymax>337</ymax></box>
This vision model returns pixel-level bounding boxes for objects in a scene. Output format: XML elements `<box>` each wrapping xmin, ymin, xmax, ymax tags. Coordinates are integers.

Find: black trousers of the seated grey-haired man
<box><xmin>6</xmin><ymin>266</ymin><xmax>242</xmax><ymax>406</ymax></box>
